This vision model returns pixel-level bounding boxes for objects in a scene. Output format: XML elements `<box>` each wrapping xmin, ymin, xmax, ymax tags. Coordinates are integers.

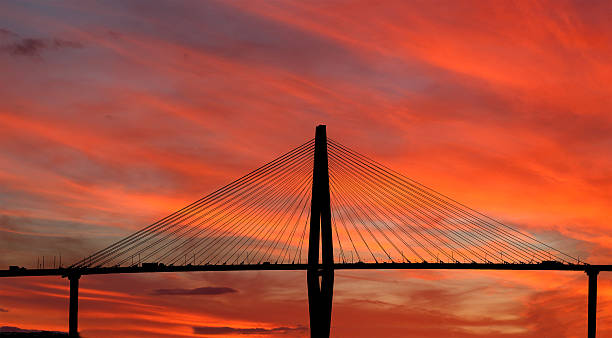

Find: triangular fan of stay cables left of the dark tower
<box><xmin>72</xmin><ymin>140</ymin><xmax>314</xmax><ymax>268</ymax></box>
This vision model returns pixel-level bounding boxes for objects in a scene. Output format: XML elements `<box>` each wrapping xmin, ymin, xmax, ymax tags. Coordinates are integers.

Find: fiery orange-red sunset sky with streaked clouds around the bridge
<box><xmin>0</xmin><ymin>0</ymin><xmax>612</xmax><ymax>338</ymax></box>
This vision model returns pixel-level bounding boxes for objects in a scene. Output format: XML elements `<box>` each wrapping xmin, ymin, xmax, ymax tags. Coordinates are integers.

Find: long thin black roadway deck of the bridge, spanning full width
<box><xmin>0</xmin><ymin>263</ymin><xmax>612</xmax><ymax>277</ymax></box>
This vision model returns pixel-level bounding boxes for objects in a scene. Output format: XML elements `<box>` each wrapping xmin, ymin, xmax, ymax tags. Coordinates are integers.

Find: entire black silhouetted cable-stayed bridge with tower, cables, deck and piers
<box><xmin>0</xmin><ymin>125</ymin><xmax>612</xmax><ymax>338</ymax></box>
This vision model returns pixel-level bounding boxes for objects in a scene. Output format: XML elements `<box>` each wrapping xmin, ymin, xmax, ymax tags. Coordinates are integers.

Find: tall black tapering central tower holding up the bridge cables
<box><xmin>306</xmin><ymin>125</ymin><xmax>334</xmax><ymax>338</ymax></box>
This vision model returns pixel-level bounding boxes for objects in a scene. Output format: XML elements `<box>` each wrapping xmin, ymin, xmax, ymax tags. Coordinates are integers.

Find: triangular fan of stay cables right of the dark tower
<box><xmin>328</xmin><ymin>139</ymin><xmax>578</xmax><ymax>264</ymax></box>
